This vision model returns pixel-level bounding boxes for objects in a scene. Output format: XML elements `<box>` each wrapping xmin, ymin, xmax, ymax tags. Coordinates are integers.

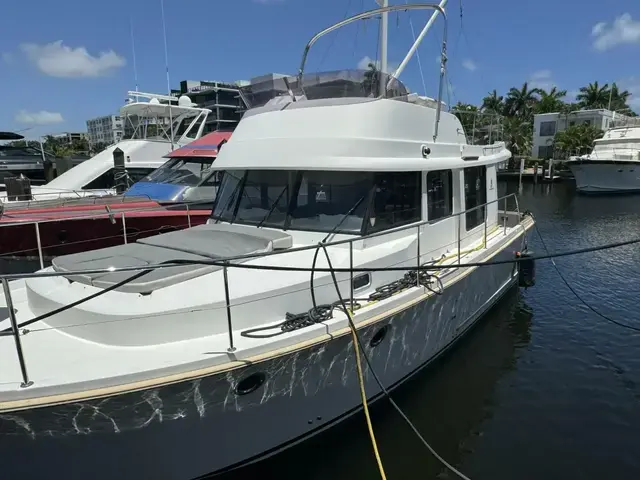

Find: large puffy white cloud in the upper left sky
<box><xmin>20</xmin><ymin>40</ymin><xmax>126</xmax><ymax>77</ymax></box>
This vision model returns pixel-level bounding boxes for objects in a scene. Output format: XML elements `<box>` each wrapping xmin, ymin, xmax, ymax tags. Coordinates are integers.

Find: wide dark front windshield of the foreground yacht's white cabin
<box><xmin>211</xmin><ymin>170</ymin><xmax>373</xmax><ymax>233</ymax></box>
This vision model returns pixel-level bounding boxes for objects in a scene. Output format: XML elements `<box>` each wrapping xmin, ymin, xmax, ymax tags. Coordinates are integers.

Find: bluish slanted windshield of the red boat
<box><xmin>141</xmin><ymin>157</ymin><xmax>219</xmax><ymax>187</ymax></box>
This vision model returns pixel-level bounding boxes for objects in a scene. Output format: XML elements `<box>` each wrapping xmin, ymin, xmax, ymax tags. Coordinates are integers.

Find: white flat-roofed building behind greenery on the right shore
<box><xmin>531</xmin><ymin>108</ymin><xmax>626</xmax><ymax>159</ymax></box>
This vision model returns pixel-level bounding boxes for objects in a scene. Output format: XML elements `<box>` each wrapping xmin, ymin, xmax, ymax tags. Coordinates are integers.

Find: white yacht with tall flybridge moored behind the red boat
<box><xmin>0</xmin><ymin>92</ymin><xmax>211</xmax><ymax>208</ymax></box>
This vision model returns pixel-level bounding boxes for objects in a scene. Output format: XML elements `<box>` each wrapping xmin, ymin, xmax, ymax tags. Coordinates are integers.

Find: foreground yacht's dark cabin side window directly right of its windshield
<box><xmin>367</xmin><ymin>172</ymin><xmax>422</xmax><ymax>232</ymax></box>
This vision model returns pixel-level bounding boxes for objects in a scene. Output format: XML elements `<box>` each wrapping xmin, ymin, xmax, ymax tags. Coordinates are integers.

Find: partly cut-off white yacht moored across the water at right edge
<box><xmin>566</xmin><ymin>117</ymin><xmax>640</xmax><ymax>193</ymax></box>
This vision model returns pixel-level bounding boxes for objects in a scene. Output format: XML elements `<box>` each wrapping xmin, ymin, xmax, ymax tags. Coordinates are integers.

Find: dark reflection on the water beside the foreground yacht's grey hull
<box><xmin>210</xmin><ymin>290</ymin><xmax>532</xmax><ymax>480</ymax></box>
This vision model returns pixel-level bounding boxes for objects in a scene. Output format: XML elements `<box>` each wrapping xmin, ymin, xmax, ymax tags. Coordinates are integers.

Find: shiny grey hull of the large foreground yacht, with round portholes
<box><xmin>0</xmin><ymin>236</ymin><xmax>522</xmax><ymax>479</ymax></box>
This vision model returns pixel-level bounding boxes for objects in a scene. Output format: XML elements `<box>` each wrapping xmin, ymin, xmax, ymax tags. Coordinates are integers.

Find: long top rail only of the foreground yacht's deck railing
<box><xmin>0</xmin><ymin>193</ymin><xmax>520</xmax><ymax>280</ymax></box>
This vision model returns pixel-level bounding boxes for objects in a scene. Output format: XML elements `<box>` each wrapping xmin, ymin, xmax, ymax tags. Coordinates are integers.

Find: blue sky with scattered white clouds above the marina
<box><xmin>0</xmin><ymin>0</ymin><xmax>640</xmax><ymax>138</ymax></box>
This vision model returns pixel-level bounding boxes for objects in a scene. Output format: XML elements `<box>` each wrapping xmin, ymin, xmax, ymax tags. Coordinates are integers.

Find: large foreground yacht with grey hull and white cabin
<box><xmin>0</xmin><ymin>4</ymin><xmax>533</xmax><ymax>479</ymax></box>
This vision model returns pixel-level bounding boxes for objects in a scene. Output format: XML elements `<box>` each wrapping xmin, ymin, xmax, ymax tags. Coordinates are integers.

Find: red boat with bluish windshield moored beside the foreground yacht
<box><xmin>0</xmin><ymin>132</ymin><xmax>231</xmax><ymax>264</ymax></box>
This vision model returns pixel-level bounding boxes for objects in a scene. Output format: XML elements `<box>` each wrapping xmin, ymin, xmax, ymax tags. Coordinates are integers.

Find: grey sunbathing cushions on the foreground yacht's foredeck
<box><xmin>52</xmin><ymin>224</ymin><xmax>293</xmax><ymax>294</ymax></box>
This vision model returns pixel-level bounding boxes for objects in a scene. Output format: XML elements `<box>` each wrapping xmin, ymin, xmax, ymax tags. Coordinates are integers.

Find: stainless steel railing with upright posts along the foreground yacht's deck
<box><xmin>0</xmin><ymin>193</ymin><xmax>520</xmax><ymax>388</ymax></box>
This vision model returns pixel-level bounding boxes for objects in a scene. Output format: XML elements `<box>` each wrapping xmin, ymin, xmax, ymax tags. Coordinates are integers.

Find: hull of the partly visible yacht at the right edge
<box><xmin>567</xmin><ymin>160</ymin><xmax>640</xmax><ymax>194</ymax></box>
